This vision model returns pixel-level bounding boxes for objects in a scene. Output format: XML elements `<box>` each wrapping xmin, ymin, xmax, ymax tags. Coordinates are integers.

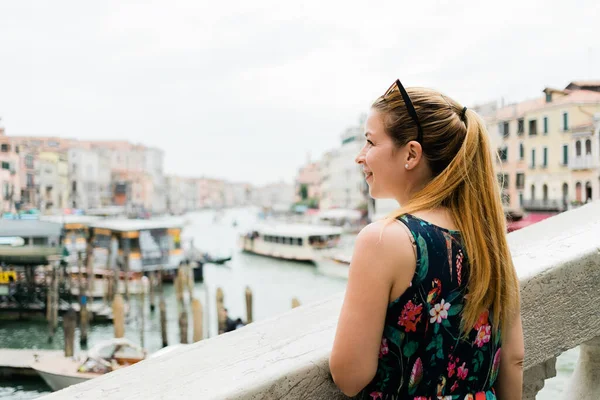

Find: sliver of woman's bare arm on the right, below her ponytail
<box><xmin>496</xmin><ymin>306</ymin><xmax>525</xmax><ymax>400</ymax></box>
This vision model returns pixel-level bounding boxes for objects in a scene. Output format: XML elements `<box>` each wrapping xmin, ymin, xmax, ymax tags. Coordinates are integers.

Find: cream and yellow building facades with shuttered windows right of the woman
<box><xmin>487</xmin><ymin>84</ymin><xmax>600</xmax><ymax>211</ymax></box>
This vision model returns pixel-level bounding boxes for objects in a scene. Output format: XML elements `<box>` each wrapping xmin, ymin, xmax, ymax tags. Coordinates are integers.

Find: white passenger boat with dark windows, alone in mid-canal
<box><xmin>240</xmin><ymin>223</ymin><xmax>343</xmax><ymax>262</ymax></box>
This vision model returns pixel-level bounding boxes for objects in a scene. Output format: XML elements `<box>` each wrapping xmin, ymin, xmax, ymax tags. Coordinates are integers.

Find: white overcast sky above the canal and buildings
<box><xmin>0</xmin><ymin>0</ymin><xmax>600</xmax><ymax>184</ymax></box>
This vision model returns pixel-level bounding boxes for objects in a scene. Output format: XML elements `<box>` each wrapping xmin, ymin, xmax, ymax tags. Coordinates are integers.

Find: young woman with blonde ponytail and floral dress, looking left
<box><xmin>329</xmin><ymin>81</ymin><xmax>524</xmax><ymax>400</ymax></box>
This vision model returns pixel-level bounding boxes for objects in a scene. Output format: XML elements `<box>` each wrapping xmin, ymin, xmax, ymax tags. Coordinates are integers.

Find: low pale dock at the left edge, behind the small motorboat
<box><xmin>0</xmin><ymin>349</ymin><xmax>64</xmax><ymax>379</ymax></box>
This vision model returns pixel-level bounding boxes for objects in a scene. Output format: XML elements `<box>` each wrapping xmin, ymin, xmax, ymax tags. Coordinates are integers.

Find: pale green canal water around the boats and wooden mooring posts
<box><xmin>0</xmin><ymin>209</ymin><xmax>578</xmax><ymax>400</ymax></box>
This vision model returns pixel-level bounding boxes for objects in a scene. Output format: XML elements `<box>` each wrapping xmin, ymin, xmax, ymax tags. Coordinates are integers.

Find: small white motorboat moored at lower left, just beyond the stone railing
<box><xmin>31</xmin><ymin>338</ymin><xmax>147</xmax><ymax>391</ymax></box>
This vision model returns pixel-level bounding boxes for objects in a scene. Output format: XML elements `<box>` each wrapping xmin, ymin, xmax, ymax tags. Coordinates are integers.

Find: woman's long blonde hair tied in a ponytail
<box><xmin>372</xmin><ymin>88</ymin><xmax>519</xmax><ymax>334</ymax></box>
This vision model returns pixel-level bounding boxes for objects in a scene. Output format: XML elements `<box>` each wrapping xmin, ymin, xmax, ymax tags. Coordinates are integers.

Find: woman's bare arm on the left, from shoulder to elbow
<box><xmin>329</xmin><ymin>223</ymin><xmax>415</xmax><ymax>397</ymax></box>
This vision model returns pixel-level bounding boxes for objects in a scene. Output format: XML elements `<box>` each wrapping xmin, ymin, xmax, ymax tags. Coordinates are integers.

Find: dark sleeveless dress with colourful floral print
<box><xmin>359</xmin><ymin>214</ymin><xmax>501</xmax><ymax>400</ymax></box>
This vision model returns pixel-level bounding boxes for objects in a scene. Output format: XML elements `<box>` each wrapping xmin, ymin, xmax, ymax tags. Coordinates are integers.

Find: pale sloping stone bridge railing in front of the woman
<box><xmin>44</xmin><ymin>202</ymin><xmax>600</xmax><ymax>400</ymax></box>
